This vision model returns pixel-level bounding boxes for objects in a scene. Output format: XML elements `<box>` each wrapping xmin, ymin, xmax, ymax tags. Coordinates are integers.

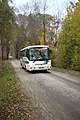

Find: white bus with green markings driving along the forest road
<box><xmin>20</xmin><ymin>45</ymin><xmax>51</xmax><ymax>71</ymax></box>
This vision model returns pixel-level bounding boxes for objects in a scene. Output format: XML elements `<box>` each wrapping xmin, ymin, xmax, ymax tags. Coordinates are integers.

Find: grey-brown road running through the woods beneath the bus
<box><xmin>11</xmin><ymin>60</ymin><xmax>80</xmax><ymax>120</ymax></box>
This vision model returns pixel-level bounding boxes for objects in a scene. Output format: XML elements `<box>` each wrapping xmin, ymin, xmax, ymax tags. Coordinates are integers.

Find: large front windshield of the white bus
<box><xmin>29</xmin><ymin>47</ymin><xmax>50</xmax><ymax>61</ymax></box>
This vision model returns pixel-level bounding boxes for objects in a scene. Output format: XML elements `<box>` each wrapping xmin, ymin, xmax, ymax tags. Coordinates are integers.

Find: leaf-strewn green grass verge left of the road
<box><xmin>0</xmin><ymin>61</ymin><xmax>38</xmax><ymax>120</ymax></box>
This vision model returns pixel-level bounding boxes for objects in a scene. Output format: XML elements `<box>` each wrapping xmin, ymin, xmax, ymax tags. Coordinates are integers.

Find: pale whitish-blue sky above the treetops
<box><xmin>13</xmin><ymin>0</ymin><xmax>77</xmax><ymax>15</ymax></box>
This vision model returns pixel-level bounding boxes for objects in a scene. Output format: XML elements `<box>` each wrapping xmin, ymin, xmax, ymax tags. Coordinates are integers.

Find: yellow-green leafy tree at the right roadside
<box><xmin>58</xmin><ymin>2</ymin><xmax>80</xmax><ymax>70</ymax></box>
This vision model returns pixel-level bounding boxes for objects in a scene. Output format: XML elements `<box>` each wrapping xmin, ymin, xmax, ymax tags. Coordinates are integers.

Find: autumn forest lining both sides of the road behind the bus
<box><xmin>0</xmin><ymin>0</ymin><xmax>80</xmax><ymax>71</ymax></box>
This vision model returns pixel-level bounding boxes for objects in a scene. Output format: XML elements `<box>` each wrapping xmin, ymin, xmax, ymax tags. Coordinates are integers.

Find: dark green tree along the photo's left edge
<box><xmin>0</xmin><ymin>0</ymin><xmax>14</xmax><ymax>59</ymax></box>
